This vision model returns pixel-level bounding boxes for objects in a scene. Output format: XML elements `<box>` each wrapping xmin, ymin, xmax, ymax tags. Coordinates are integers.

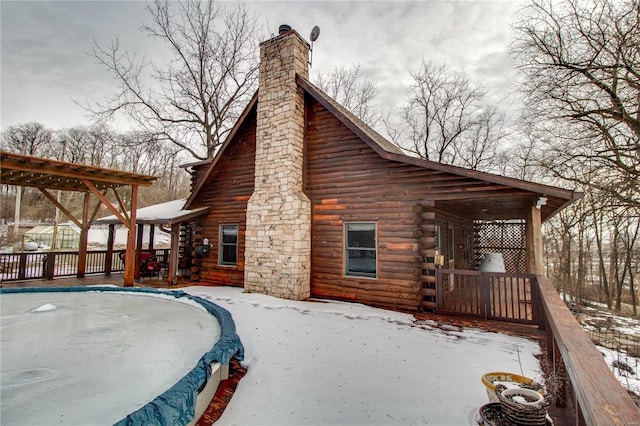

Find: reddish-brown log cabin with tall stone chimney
<box><xmin>184</xmin><ymin>26</ymin><xmax>581</xmax><ymax>310</ymax></box>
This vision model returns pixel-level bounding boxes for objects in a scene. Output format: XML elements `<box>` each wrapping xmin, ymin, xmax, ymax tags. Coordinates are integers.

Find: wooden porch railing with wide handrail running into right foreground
<box><xmin>436</xmin><ymin>269</ymin><xmax>640</xmax><ymax>426</ymax></box>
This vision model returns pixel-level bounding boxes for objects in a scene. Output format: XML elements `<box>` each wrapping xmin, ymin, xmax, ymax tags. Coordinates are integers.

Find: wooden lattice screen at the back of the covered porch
<box><xmin>473</xmin><ymin>220</ymin><xmax>527</xmax><ymax>273</ymax></box>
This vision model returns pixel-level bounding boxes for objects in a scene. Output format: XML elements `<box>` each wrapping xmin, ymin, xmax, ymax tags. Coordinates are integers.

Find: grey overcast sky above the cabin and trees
<box><xmin>0</xmin><ymin>0</ymin><xmax>520</xmax><ymax>130</ymax></box>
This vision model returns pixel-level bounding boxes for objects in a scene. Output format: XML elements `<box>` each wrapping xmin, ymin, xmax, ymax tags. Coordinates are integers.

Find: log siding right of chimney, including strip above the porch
<box><xmin>305</xmin><ymin>96</ymin><xmax>530</xmax><ymax>309</ymax></box>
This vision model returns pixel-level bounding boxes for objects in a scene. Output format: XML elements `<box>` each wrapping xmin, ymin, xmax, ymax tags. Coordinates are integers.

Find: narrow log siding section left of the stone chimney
<box><xmin>192</xmin><ymin>113</ymin><xmax>256</xmax><ymax>286</ymax></box>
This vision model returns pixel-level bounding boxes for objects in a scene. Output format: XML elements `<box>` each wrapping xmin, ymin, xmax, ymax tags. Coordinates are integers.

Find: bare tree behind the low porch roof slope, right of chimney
<box><xmin>387</xmin><ymin>60</ymin><xmax>505</xmax><ymax>170</ymax></box>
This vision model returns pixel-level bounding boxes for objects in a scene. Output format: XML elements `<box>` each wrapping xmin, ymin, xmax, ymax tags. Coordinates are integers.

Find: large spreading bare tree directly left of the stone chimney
<box><xmin>88</xmin><ymin>0</ymin><xmax>258</xmax><ymax>159</ymax></box>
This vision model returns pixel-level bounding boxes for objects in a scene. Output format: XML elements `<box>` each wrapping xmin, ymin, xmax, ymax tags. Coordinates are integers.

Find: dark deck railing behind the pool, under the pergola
<box><xmin>0</xmin><ymin>249</ymin><xmax>170</xmax><ymax>281</ymax></box>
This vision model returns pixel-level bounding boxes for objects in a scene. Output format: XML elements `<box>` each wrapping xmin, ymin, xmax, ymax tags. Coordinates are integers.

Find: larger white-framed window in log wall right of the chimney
<box><xmin>344</xmin><ymin>222</ymin><xmax>378</xmax><ymax>278</ymax></box>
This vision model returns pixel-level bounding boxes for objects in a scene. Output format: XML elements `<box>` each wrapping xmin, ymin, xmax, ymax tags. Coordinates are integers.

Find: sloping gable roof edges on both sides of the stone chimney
<box><xmin>185</xmin><ymin>75</ymin><xmax>582</xmax><ymax>220</ymax></box>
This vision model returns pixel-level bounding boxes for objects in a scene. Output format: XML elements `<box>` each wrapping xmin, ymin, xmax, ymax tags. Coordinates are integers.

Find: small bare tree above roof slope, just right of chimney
<box><xmin>314</xmin><ymin>64</ymin><xmax>381</xmax><ymax>127</ymax></box>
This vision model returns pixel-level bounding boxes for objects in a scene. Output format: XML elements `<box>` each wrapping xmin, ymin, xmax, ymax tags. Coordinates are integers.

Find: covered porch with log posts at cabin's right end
<box><xmin>418</xmin><ymin>170</ymin><xmax>582</xmax><ymax>312</ymax></box>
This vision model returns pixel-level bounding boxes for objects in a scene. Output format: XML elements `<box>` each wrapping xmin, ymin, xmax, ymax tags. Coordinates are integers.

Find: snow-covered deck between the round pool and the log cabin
<box><xmin>184</xmin><ymin>287</ymin><xmax>540</xmax><ymax>425</ymax></box>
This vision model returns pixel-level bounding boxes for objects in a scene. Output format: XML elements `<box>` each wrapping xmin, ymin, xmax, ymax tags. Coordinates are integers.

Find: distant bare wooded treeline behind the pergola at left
<box><xmin>0</xmin><ymin>123</ymin><xmax>190</xmax><ymax>223</ymax></box>
